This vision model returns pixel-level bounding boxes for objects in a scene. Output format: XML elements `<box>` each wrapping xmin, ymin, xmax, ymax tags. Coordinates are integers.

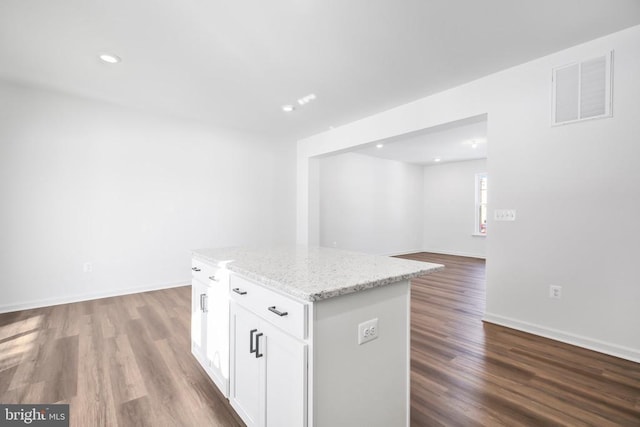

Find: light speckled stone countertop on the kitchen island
<box><xmin>192</xmin><ymin>246</ymin><xmax>444</xmax><ymax>301</ymax></box>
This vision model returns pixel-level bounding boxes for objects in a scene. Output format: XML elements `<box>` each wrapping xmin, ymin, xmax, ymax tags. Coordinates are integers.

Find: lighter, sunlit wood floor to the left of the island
<box><xmin>0</xmin><ymin>286</ymin><xmax>243</xmax><ymax>427</ymax></box>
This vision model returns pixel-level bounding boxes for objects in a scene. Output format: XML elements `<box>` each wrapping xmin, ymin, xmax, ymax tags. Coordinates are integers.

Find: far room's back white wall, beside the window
<box><xmin>423</xmin><ymin>159</ymin><xmax>487</xmax><ymax>258</ymax></box>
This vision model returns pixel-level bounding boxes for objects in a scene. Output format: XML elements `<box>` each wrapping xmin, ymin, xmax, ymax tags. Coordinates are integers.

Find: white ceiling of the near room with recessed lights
<box><xmin>0</xmin><ymin>0</ymin><xmax>640</xmax><ymax>138</ymax></box>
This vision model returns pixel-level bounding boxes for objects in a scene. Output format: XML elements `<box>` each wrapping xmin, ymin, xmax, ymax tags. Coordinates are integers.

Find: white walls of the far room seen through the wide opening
<box><xmin>318</xmin><ymin>153</ymin><xmax>486</xmax><ymax>258</ymax></box>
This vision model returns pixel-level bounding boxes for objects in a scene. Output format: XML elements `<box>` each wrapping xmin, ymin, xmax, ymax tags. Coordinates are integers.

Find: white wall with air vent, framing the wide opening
<box><xmin>297</xmin><ymin>26</ymin><xmax>640</xmax><ymax>361</ymax></box>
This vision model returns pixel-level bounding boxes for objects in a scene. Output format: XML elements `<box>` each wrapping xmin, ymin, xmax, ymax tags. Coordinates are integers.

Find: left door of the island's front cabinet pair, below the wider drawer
<box><xmin>229</xmin><ymin>303</ymin><xmax>266</xmax><ymax>427</ymax></box>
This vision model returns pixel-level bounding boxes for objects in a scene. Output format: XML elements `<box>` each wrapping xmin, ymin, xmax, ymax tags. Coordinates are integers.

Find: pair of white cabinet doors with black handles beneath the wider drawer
<box><xmin>229</xmin><ymin>298</ymin><xmax>307</xmax><ymax>427</ymax></box>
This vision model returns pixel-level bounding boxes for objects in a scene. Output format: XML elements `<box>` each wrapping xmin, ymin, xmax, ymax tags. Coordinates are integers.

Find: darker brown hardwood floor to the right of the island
<box><xmin>402</xmin><ymin>253</ymin><xmax>640</xmax><ymax>426</ymax></box>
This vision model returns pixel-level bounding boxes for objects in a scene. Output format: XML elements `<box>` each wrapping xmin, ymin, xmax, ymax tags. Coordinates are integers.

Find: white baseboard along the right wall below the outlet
<box><xmin>482</xmin><ymin>313</ymin><xmax>640</xmax><ymax>363</ymax></box>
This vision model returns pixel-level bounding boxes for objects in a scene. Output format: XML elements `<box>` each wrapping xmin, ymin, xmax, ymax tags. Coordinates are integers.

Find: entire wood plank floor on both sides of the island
<box><xmin>0</xmin><ymin>253</ymin><xmax>640</xmax><ymax>427</ymax></box>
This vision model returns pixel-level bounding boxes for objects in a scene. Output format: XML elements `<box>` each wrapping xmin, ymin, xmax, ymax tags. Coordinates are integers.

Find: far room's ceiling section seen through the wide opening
<box><xmin>353</xmin><ymin>115</ymin><xmax>488</xmax><ymax>166</ymax></box>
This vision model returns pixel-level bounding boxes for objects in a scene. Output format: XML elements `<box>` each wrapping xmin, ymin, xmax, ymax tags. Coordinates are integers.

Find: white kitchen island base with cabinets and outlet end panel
<box><xmin>191</xmin><ymin>254</ymin><xmax>410</xmax><ymax>427</ymax></box>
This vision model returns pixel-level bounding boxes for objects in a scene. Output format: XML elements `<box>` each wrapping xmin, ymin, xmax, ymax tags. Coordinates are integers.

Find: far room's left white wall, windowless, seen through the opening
<box><xmin>319</xmin><ymin>153</ymin><xmax>422</xmax><ymax>254</ymax></box>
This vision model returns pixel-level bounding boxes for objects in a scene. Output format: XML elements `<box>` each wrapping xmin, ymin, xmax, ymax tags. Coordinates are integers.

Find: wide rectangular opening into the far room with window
<box><xmin>314</xmin><ymin>114</ymin><xmax>488</xmax><ymax>258</ymax></box>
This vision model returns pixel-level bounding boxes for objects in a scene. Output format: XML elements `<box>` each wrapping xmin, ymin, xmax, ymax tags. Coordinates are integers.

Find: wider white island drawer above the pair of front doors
<box><xmin>229</xmin><ymin>274</ymin><xmax>307</xmax><ymax>339</ymax></box>
